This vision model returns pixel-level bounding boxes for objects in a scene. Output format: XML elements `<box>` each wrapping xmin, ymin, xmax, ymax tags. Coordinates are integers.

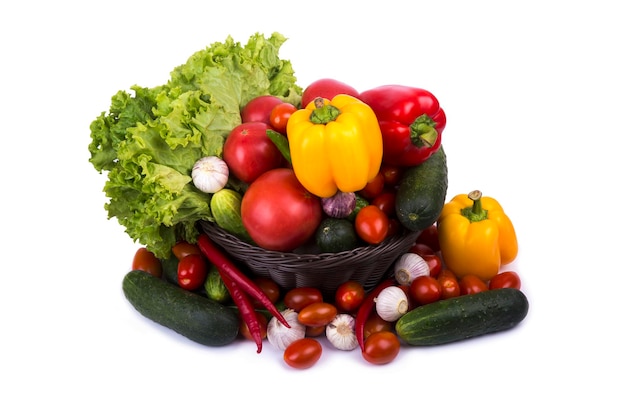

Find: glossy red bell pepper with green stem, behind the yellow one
<box><xmin>359</xmin><ymin>85</ymin><xmax>446</xmax><ymax>167</ymax></box>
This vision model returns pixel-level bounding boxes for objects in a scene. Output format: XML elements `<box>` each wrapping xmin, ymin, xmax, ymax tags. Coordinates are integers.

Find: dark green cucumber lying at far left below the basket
<box><xmin>122</xmin><ymin>271</ymin><xmax>239</xmax><ymax>346</ymax></box>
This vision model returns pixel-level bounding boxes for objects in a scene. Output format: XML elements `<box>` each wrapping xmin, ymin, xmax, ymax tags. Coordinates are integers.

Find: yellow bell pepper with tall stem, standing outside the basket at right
<box><xmin>437</xmin><ymin>191</ymin><xmax>518</xmax><ymax>281</ymax></box>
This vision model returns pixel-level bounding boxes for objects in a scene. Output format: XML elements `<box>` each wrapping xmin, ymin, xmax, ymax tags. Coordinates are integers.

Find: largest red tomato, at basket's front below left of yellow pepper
<box><xmin>241</xmin><ymin>168</ymin><xmax>323</xmax><ymax>252</ymax></box>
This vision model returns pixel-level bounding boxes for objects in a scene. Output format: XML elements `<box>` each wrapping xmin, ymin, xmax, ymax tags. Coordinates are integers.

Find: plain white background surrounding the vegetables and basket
<box><xmin>0</xmin><ymin>0</ymin><xmax>626</xmax><ymax>416</ymax></box>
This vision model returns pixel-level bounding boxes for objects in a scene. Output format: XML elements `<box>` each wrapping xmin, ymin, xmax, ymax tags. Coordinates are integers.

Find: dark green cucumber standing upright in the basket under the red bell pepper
<box><xmin>396</xmin><ymin>147</ymin><xmax>448</xmax><ymax>232</ymax></box>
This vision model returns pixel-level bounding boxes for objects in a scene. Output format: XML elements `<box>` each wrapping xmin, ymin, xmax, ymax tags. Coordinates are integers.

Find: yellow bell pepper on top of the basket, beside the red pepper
<box><xmin>287</xmin><ymin>94</ymin><xmax>383</xmax><ymax>197</ymax></box>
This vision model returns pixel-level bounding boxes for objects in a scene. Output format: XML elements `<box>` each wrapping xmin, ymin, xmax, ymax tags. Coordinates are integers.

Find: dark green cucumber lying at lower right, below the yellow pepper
<box><xmin>396</xmin><ymin>288</ymin><xmax>528</xmax><ymax>346</ymax></box>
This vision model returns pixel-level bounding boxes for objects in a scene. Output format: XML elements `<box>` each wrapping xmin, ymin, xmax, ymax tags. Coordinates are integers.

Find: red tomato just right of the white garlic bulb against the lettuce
<box><xmin>223</xmin><ymin>122</ymin><xmax>285</xmax><ymax>184</ymax></box>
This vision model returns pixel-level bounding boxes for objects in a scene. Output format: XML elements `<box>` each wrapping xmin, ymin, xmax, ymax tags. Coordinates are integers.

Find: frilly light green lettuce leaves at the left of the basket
<box><xmin>89</xmin><ymin>33</ymin><xmax>302</xmax><ymax>258</ymax></box>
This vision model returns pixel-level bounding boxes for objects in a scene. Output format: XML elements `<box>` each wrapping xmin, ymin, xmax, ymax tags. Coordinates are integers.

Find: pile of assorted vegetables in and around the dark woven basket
<box><xmin>89</xmin><ymin>33</ymin><xmax>528</xmax><ymax>369</ymax></box>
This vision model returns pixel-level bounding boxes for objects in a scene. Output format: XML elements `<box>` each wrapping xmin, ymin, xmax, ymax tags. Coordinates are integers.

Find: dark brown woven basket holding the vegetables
<box><xmin>199</xmin><ymin>221</ymin><xmax>420</xmax><ymax>295</ymax></box>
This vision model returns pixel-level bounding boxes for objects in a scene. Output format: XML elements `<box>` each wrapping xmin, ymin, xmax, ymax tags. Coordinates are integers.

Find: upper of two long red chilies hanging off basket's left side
<box><xmin>198</xmin><ymin>234</ymin><xmax>291</xmax><ymax>328</ymax></box>
